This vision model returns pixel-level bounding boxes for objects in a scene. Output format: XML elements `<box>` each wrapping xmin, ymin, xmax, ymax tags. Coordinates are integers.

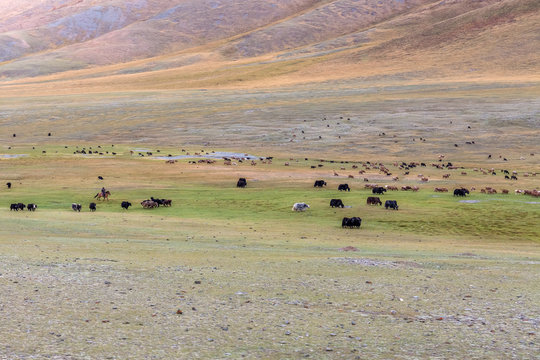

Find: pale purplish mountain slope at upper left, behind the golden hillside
<box><xmin>0</xmin><ymin>0</ymin><xmax>324</xmax><ymax>76</ymax></box>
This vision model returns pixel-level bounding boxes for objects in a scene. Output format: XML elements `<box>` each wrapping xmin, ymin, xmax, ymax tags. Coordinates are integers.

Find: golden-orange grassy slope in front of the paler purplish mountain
<box><xmin>1</xmin><ymin>1</ymin><xmax>540</xmax><ymax>96</ymax></box>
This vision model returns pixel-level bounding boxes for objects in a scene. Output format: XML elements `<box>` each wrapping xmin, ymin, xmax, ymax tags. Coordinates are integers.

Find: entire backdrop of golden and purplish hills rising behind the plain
<box><xmin>0</xmin><ymin>0</ymin><xmax>540</xmax><ymax>92</ymax></box>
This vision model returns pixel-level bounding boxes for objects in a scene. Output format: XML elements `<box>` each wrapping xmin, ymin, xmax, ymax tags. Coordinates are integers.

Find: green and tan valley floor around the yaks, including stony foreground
<box><xmin>0</xmin><ymin>148</ymin><xmax>540</xmax><ymax>359</ymax></box>
